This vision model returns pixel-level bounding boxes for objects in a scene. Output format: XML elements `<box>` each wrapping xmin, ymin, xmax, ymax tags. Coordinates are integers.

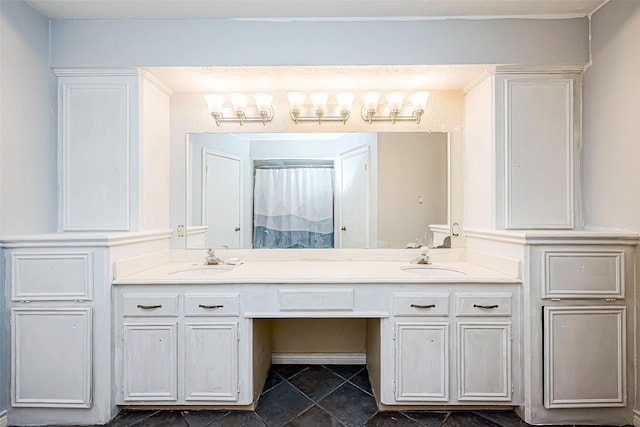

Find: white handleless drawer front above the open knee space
<box><xmin>278</xmin><ymin>288</ymin><xmax>353</xmax><ymax>311</ymax></box>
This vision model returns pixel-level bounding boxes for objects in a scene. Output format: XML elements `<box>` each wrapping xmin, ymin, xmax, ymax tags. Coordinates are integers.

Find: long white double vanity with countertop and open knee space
<box><xmin>113</xmin><ymin>250</ymin><xmax>520</xmax><ymax>407</ymax></box>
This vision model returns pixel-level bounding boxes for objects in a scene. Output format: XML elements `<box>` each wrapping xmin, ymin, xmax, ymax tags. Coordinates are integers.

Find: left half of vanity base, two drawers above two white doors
<box><xmin>116</xmin><ymin>285</ymin><xmax>251</xmax><ymax>405</ymax></box>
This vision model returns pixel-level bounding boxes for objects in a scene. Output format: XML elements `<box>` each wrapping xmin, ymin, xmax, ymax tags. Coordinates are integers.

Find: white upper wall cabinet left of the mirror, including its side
<box><xmin>56</xmin><ymin>70</ymin><xmax>169</xmax><ymax>231</ymax></box>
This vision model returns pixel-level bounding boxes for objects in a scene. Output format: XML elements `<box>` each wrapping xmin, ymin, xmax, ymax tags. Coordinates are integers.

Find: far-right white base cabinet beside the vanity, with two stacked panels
<box><xmin>523</xmin><ymin>242</ymin><xmax>637</xmax><ymax>424</ymax></box>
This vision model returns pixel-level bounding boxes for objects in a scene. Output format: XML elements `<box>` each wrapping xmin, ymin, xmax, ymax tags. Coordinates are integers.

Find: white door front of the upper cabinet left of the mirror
<box><xmin>59</xmin><ymin>76</ymin><xmax>138</xmax><ymax>231</ymax></box>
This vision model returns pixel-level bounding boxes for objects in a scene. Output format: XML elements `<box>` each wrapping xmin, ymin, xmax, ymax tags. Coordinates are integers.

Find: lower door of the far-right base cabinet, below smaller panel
<box><xmin>544</xmin><ymin>307</ymin><xmax>626</xmax><ymax>408</ymax></box>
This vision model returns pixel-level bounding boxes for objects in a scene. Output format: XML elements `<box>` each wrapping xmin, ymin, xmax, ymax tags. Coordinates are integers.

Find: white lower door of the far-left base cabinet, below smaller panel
<box><xmin>11</xmin><ymin>307</ymin><xmax>92</xmax><ymax>408</ymax></box>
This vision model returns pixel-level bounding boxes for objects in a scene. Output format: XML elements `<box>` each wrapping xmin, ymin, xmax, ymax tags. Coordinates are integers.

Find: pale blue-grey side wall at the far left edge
<box><xmin>0</xmin><ymin>1</ymin><xmax>57</xmax><ymax>414</ymax></box>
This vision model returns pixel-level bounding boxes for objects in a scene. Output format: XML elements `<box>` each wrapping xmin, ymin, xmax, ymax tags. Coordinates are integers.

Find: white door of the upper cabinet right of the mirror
<box><xmin>504</xmin><ymin>76</ymin><xmax>579</xmax><ymax>229</ymax></box>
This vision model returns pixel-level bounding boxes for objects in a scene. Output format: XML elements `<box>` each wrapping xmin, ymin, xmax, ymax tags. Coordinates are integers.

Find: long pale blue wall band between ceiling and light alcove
<box><xmin>51</xmin><ymin>18</ymin><xmax>589</xmax><ymax>67</ymax></box>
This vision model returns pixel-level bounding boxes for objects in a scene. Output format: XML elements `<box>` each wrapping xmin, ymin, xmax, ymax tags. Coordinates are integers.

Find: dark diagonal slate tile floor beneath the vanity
<box><xmin>18</xmin><ymin>365</ymin><xmax>632</xmax><ymax>427</ymax></box>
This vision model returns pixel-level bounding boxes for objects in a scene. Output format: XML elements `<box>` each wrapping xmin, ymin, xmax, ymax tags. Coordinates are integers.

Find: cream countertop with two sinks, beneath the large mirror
<box><xmin>113</xmin><ymin>260</ymin><xmax>521</xmax><ymax>285</ymax></box>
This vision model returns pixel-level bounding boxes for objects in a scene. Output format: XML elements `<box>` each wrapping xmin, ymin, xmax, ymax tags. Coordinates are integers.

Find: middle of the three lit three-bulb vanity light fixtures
<box><xmin>287</xmin><ymin>92</ymin><xmax>355</xmax><ymax>124</ymax></box>
